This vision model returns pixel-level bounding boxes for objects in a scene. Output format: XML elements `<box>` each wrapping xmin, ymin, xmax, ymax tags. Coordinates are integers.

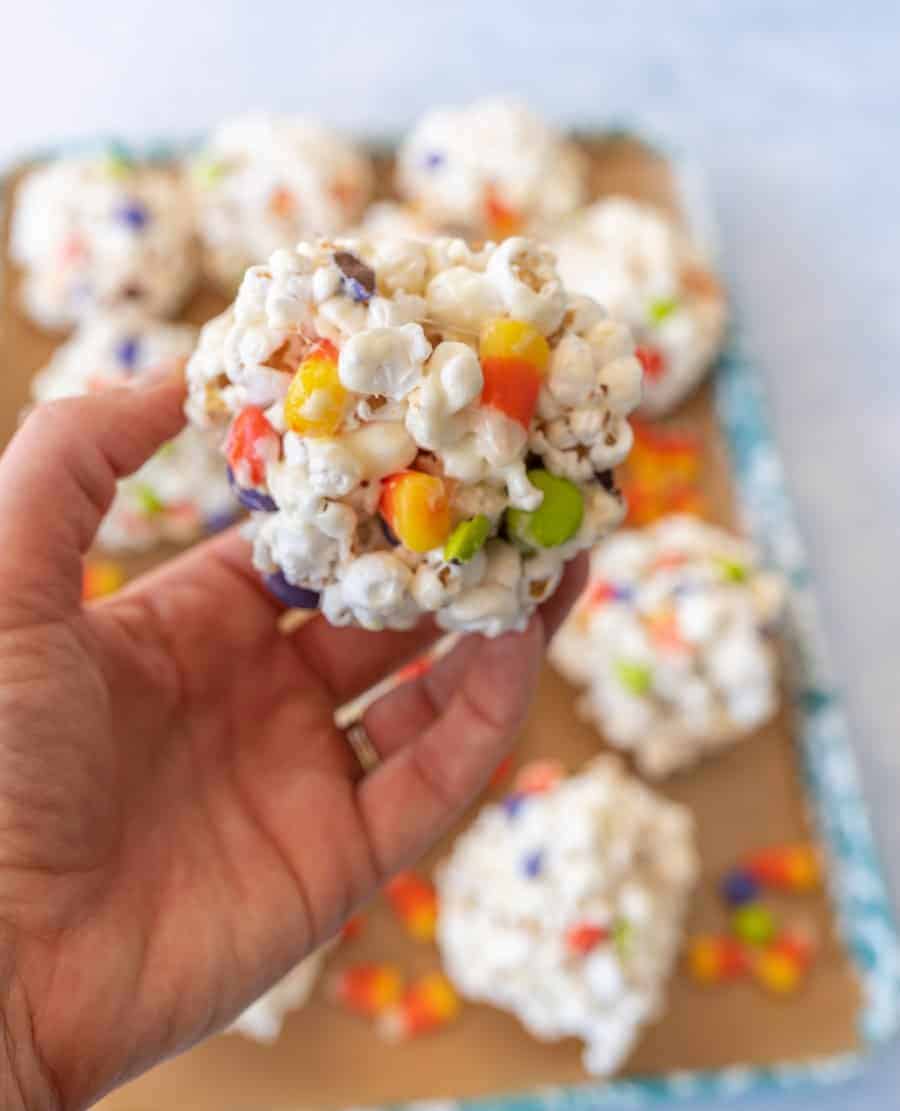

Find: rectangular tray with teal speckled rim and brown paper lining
<box><xmin>0</xmin><ymin>129</ymin><xmax>900</xmax><ymax>1111</ymax></box>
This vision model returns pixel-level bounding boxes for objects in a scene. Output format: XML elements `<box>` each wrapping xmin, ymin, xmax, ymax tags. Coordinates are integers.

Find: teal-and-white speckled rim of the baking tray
<box><xmin>0</xmin><ymin>124</ymin><xmax>900</xmax><ymax>1111</ymax></box>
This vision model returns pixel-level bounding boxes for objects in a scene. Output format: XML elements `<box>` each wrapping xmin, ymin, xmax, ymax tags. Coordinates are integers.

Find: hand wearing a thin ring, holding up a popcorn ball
<box><xmin>0</xmin><ymin>378</ymin><xmax>584</xmax><ymax>1109</ymax></box>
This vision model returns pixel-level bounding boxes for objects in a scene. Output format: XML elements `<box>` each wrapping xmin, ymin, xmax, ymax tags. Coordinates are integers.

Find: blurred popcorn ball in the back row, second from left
<box><xmin>191</xmin><ymin>114</ymin><xmax>372</xmax><ymax>290</ymax></box>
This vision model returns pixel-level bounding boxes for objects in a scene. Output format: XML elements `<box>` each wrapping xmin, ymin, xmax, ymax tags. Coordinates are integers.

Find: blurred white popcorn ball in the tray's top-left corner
<box><xmin>10</xmin><ymin>150</ymin><xmax>198</xmax><ymax>329</ymax></box>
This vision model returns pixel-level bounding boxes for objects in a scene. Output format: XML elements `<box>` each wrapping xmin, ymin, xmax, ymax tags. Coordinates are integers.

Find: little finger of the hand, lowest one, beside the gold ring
<box><xmin>358</xmin><ymin>617</ymin><xmax>544</xmax><ymax>874</ymax></box>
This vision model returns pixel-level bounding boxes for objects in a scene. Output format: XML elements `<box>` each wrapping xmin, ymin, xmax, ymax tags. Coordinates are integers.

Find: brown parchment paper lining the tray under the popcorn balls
<box><xmin>0</xmin><ymin>139</ymin><xmax>860</xmax><ymax>1111</ymax></box>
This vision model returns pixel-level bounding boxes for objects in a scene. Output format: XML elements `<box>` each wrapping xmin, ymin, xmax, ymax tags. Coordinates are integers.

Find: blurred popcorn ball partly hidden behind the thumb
<box><xmin>31</xmin><ymin>310</ymin><xmax>238</xmax><ymax>550</ymax></box>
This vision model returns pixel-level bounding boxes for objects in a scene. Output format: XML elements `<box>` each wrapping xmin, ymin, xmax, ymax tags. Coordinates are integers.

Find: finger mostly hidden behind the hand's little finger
<box><xmin>363</xmin><ymin>552</ymin><xmax>588</xmax><ymax>759</ymax></box>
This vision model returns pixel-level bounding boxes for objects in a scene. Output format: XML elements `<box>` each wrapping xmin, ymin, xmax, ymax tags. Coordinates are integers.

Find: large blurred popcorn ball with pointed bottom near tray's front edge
<box><xmin>437</xmin><ymin>758</ymin><xmax>698</xmax><ymax>1075</ymax></box>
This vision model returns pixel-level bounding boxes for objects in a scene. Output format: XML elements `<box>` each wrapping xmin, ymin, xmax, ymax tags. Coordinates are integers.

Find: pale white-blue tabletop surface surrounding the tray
<box><xmin>0</xmin><ymin>0</ymin><xmax>900</xmax><ymax>1111</ymax></box>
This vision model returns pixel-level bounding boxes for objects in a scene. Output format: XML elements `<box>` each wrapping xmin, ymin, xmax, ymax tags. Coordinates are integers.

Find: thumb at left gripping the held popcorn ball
<box><xmin>0</xmin><ymin>368</ymin><xmax>184</xmax><ymax>623</ymax></box>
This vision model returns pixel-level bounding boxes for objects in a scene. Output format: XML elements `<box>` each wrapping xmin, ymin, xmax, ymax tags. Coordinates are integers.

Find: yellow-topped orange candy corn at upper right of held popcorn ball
<box><xmin>479</xmin><ymin>317</ymin><xmax>550</xmax><ymax>428</ymax></box>
